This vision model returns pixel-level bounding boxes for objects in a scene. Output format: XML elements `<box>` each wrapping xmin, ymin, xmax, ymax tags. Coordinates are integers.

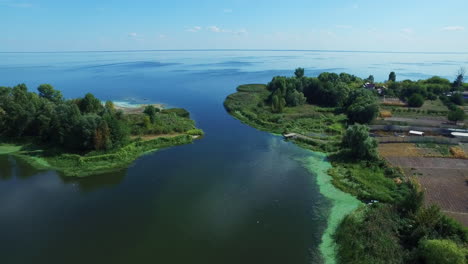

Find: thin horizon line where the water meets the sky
<box><xmin>0</xmin><ymin>49</ymin><xmax>468</xmax><ymax>54</ymax></box>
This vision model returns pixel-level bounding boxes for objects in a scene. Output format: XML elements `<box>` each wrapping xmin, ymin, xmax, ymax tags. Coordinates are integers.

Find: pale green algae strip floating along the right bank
<box><xmin>305</xmin><ymin>151</ymin><xmax>362</xmax><ymax>264</ymax></box>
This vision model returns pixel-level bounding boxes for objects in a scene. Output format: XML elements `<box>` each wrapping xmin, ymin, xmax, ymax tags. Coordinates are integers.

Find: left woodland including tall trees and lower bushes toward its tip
<box><xmin>0</xmin><ymin>84</ymin><xmax>195</xmax><ymax>153</ymax></box>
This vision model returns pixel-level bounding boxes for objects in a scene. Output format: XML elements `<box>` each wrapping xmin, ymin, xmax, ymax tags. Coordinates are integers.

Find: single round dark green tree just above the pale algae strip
<box><xmin>342</xmin><ymin>124</ymin><xmax>377</xmax><ymax>160</ymax></box>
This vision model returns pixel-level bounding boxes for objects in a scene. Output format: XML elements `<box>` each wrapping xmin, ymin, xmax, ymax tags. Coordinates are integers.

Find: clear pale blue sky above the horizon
<box><xmin>0</xmin><ymin>0</ymin><xmax>468</xmax><ymax>52</ymax></box>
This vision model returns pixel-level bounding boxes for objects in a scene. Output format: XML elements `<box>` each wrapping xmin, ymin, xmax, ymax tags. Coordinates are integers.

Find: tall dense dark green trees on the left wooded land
<box><xmin>0</xmin><ymin>84</ymin><xmax>129</xmax><ymax>151</ymax></box>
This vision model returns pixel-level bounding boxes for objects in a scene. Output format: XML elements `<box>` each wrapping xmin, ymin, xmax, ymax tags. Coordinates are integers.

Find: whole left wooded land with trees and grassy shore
<box><xmin>0</xmin><ymin>84</ymin><xmax>203</xmax><ymax>177</ymax></box>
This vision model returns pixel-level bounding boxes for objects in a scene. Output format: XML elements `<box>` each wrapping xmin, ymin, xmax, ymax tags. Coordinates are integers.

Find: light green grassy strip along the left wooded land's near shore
<box><xmin>0</xmin><ymin>135</ymin><xmax>193</xmax><ymax>177</ymax></box>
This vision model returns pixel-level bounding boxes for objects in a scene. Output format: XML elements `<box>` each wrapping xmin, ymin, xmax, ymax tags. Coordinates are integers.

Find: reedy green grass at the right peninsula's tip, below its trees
<box><xmin>224</xmin><ymin>84</ymin><xmax>346</xmax><ymax>152</ymax></box>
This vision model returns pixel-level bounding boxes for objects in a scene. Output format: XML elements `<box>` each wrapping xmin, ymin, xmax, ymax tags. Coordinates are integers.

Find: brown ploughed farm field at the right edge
<box><xmin>379</xmin><ymin>144</ymin><xmax>468</xmax><ymax>226</ymax></box>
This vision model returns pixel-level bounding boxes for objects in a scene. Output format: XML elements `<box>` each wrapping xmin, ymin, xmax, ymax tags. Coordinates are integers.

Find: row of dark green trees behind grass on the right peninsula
<box><xmin>267</xmin><ymin>68</ymin><xmax>379</xmax><ymax>123</ymax></box>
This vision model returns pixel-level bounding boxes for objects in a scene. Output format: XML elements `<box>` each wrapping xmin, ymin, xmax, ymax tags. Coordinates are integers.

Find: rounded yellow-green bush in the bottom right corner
<box><xmin>419</xmin><ymin>239</ymin><xmax>468</xmax><ymax>264</ymax></box>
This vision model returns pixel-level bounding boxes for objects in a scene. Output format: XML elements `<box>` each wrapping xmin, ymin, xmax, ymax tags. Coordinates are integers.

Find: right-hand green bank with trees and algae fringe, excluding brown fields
<box><xmin>224</xmin><ymin>68</ymin><xmax>468</xmax><ymax>263</ymax></box>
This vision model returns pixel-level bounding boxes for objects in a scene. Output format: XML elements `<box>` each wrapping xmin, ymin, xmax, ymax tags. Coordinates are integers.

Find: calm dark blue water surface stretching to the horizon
<box><xmin>0</xmin><ymin>51</ymin><xmax>468</xmax><ymax>264</ymax></box>
